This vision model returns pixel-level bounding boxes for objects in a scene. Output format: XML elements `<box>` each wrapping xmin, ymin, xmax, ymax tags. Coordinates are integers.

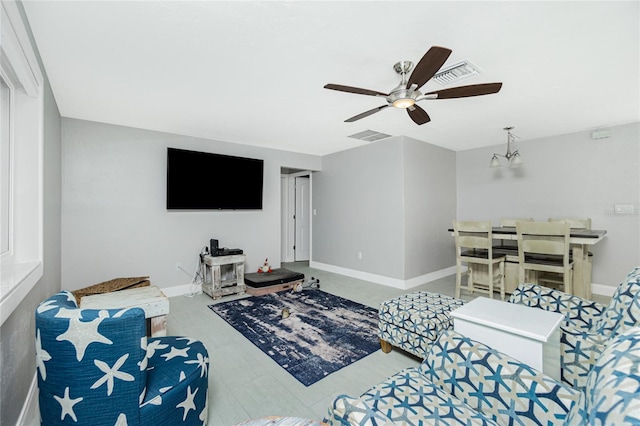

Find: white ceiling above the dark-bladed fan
<box><xmin>23</xmin><ymin>0</ymin><xmax>640</xmax><ymax>155</ymax></box>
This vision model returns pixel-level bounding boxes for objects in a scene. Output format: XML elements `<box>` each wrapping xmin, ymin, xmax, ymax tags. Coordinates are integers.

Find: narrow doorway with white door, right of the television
<box><xmin>280</xmin><ymin>169</ymin><xmax>311</xmax><ymax>262</ymax></box>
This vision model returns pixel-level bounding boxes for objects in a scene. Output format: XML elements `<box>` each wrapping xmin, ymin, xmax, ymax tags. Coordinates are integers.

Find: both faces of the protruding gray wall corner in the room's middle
<box><xmin>312</xmin><ymin>137</ymin><xmax>456</xmax><ymax>280</ymax></box>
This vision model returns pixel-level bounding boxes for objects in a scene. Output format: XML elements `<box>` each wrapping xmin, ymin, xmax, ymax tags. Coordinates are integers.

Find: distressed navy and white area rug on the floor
<box><xmin>209</xmin><ymin>290</ymin><xmax>380</xmax><ymax>386</ymax></box>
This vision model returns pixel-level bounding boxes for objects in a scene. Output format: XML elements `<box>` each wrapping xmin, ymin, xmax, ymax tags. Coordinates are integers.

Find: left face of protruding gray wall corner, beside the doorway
<box><xmin>311</xmin><ymin>138</ymin><xmax>404</xmax><ymax>278</ymax></box>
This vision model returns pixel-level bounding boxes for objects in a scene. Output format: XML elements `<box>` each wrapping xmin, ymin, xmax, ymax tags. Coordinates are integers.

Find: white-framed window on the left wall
<box><xmin>0</xmin><ymin>0</ymin><xmax>44</xmax><ymax>324</ymax></box>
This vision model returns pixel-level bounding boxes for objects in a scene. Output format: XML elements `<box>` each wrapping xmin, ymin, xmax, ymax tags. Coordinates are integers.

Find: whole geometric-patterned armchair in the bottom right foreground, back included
<box><xmin>324</xmin><ymin>327</ymin><xmax>640</xmax><ymax>426</ymax></box>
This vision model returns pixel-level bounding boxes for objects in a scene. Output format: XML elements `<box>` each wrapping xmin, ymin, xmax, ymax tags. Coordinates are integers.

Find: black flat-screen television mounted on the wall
<box><xmin>167</xmin><ymin>148</ymin><xmax>264</xmax><ymax>210</ymax></box>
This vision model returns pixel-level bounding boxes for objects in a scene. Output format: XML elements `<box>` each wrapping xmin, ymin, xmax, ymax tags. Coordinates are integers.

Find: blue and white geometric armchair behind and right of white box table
<box><xmin>509</xmin><ymin>267</ymin><xmax>640</xmax><ymax>390</ymax></box>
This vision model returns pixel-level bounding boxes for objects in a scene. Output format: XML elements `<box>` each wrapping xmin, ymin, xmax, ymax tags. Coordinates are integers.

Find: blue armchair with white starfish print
<box><xmin>35</xmin><ymin>291</ymin><xmax>209</xmax><ymax>426</ymax></box>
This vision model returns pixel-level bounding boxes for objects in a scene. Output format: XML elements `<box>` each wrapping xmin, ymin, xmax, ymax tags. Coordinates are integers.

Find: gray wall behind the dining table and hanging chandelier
<box><xmin>452</xmin><ymin>123</ymin><xmax>640</xmax><ymax>286</ymax></box>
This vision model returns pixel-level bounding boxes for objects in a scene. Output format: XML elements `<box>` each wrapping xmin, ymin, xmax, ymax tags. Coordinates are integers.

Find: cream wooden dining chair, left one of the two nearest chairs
<box><xmin>453</xmin><ymin>221</ymin><xmax>506</xmax><ymax>300</ymax></box>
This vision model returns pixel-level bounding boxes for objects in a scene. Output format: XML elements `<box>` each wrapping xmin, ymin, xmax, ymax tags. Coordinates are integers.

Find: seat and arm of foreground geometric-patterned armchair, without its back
<box><xmin>325</xmin><ymin>331</ymin><xmax>581</xmax><ymax>426</ymax></box>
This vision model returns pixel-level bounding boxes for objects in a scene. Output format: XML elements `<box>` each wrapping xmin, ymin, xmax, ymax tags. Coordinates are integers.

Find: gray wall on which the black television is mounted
<box><xmin>62</xmin><ymin>118</ymin><xmax>321</xmax><ymax>290</ymax></box>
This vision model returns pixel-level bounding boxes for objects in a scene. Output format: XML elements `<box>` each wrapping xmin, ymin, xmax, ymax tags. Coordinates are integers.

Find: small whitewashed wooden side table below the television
<box><xmin>202</xmin><ymin>254</ymin><xmax>247</xmax><ymax>299</ymax></box>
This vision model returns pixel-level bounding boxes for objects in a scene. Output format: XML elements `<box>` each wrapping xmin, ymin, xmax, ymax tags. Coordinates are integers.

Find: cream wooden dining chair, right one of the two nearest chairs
<box><xmin>516</xmin><ymin>221</ymin><xmax>573</xmax><ymax>293</ymax></box>
